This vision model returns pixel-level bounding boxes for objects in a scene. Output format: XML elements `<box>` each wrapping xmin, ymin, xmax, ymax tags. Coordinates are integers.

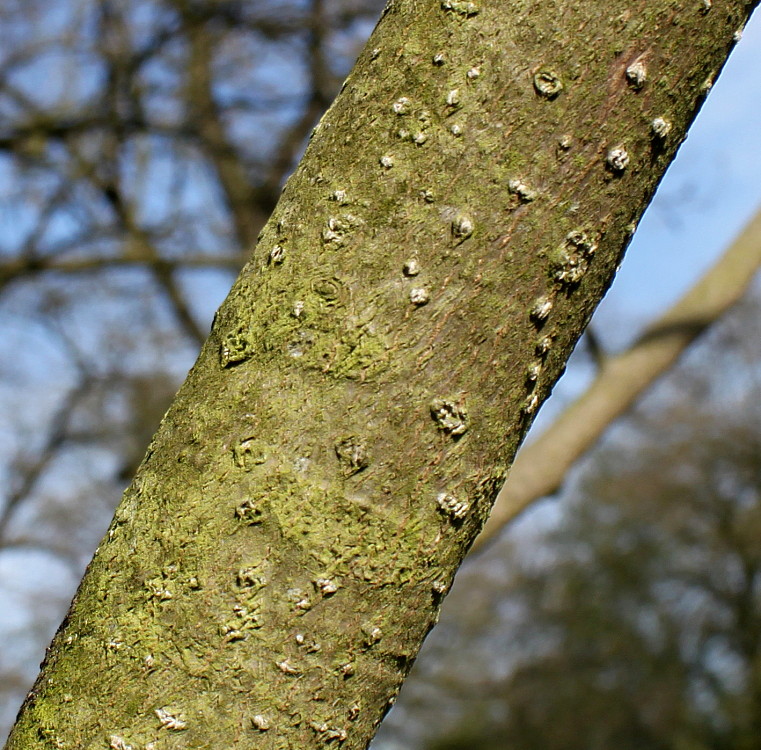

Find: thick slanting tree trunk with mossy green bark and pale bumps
<box><xmin>7</xmin><ymin>0</ymin><xmax>755</xmax><ymax>750</ymax></box>
